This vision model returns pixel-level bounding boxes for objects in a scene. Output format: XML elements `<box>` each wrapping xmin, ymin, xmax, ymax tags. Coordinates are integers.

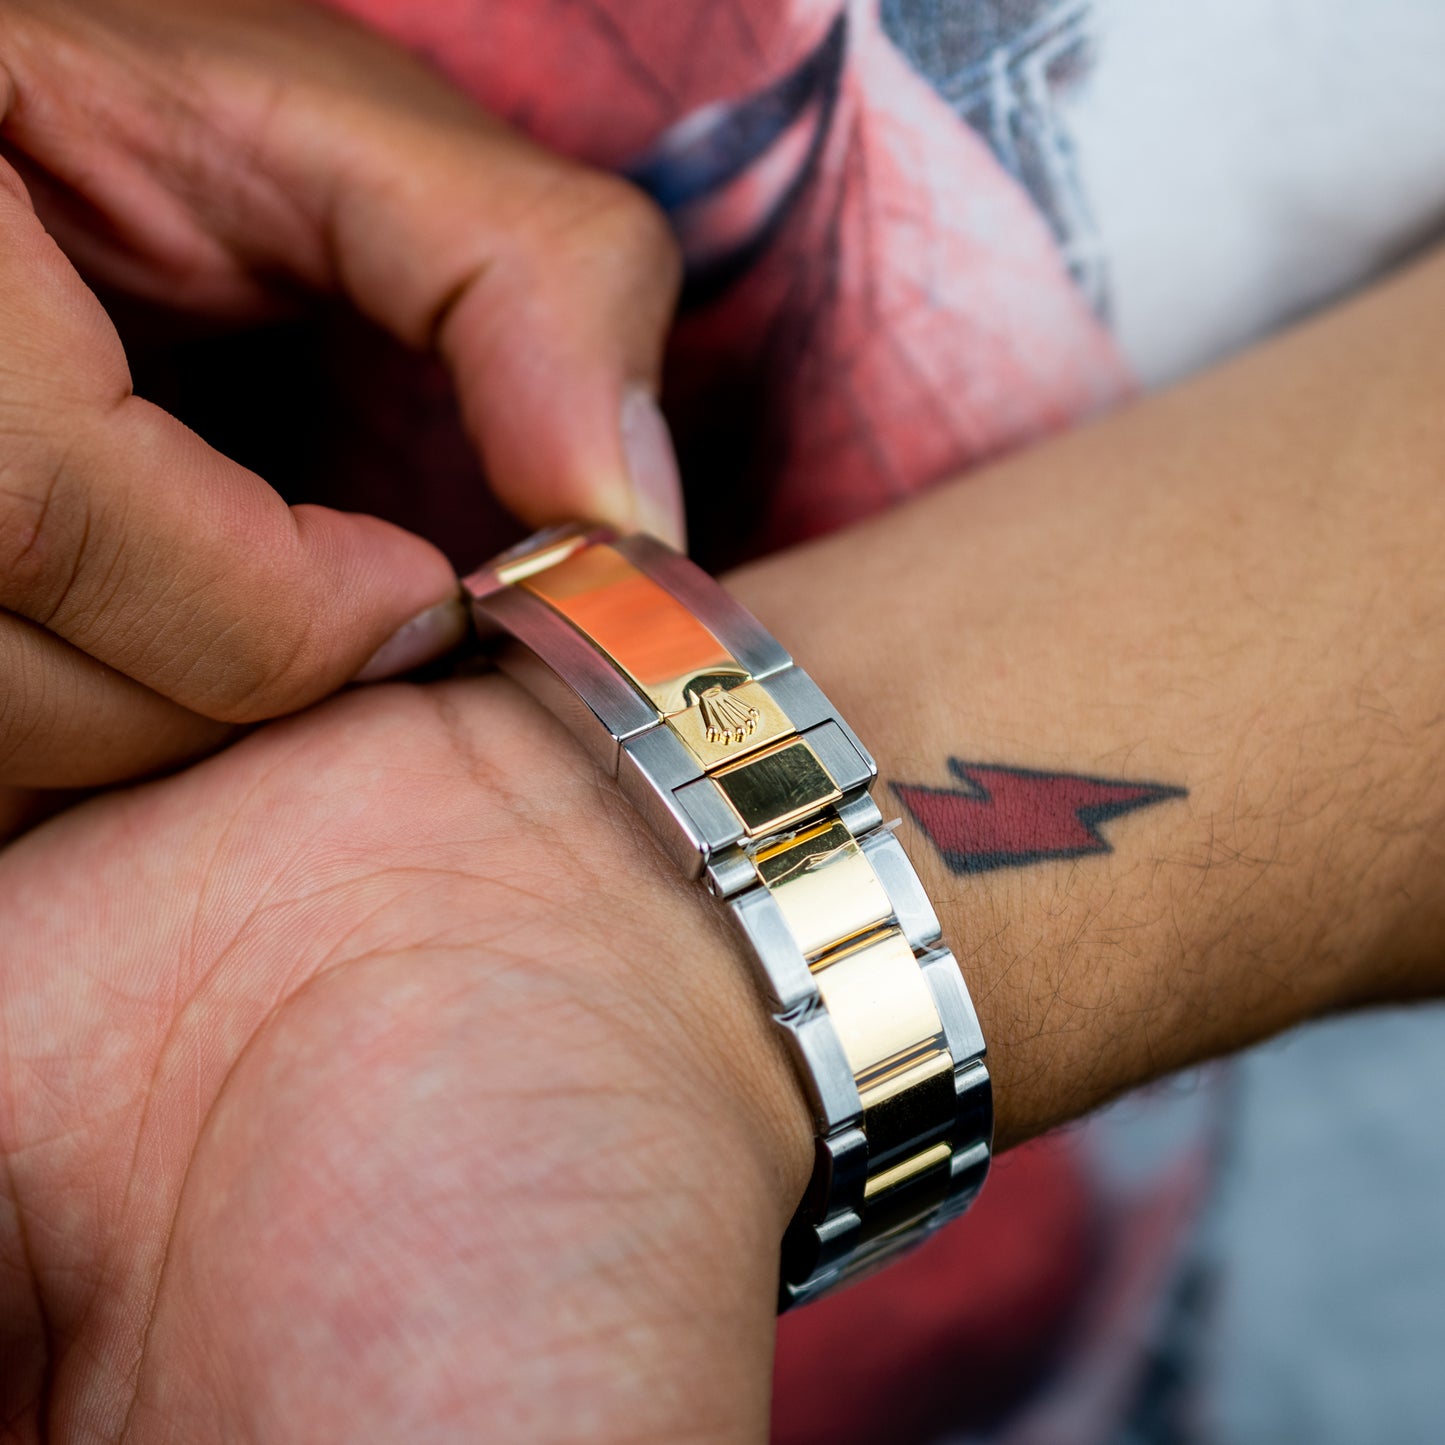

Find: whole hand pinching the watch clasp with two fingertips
<box><xmin>0</xmin><ymin>0</ymin><xmax>682</xmax><ymax>788</ymax></box>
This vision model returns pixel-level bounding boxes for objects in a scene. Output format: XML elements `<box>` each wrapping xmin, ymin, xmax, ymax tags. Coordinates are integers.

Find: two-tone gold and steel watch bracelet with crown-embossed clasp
<box><xmin>465</xmin><ymin>529</ymin><xmax>993</xmax><ymax>1309</ymax></box>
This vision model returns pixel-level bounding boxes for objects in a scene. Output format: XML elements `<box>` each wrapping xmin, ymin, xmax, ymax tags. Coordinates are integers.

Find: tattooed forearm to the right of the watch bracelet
<box><xmin>733</xmin><ymin>245</ymin><xmax>1445</xmax><ymax>1144</ymax></box>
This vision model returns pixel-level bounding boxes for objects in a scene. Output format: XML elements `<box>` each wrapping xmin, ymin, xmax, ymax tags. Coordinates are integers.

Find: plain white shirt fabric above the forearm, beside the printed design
<box><xmin>1080</xmin><ymin>0</ymin><xmax>1445</xmax><ymax>383</ymax></box>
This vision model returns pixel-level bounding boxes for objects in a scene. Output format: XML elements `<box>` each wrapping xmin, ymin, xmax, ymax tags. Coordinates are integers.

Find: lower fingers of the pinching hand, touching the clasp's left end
<box><xmin>0</xmin><ymin>151</ymin><xmax>464</xmax><ymax>786</ymax></box>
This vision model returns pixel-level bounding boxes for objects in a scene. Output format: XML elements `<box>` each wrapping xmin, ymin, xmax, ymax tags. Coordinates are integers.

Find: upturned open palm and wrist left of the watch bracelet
<box><xmin>0</xmin><ymin>679</ymin><xmax>786</xmax><ymax>1445</ymax></box>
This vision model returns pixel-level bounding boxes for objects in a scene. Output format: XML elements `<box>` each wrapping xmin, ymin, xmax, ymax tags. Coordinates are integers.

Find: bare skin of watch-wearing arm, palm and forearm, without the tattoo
<box><xmin>0</xmin><ymin>242</ymin><xmax>1445</xmax><ymax>1445</ymax></box>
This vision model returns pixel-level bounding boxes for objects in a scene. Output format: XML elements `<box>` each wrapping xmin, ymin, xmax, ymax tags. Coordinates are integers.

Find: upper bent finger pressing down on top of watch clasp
<box><xmin>9</xmin><ymin>0</ymin><xmax>682</xmax><ymax>542</ymax></box>
